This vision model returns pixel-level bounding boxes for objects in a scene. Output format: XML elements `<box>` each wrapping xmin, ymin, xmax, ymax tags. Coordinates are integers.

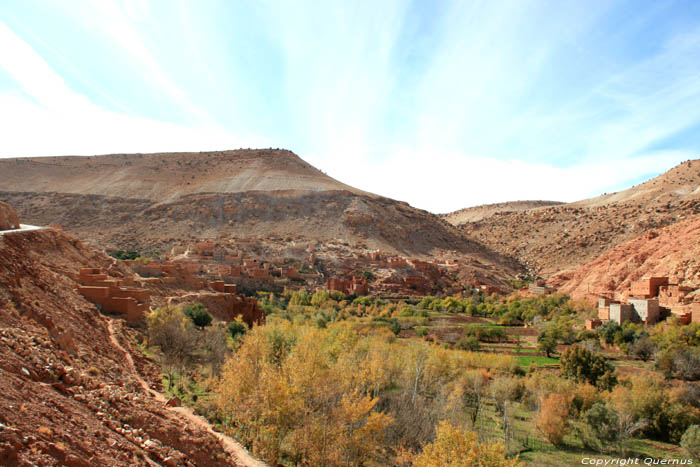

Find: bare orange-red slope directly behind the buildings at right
<box><xmin>550</xmin><ymin>216</ymin><xmax>700</xmax><ymax>299</ymax></box>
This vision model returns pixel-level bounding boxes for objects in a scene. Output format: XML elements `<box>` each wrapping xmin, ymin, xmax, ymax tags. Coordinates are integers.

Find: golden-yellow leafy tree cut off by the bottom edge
<box><xmin>413</xmin><ymin>421</ymin><xmax>523</xmax><ymax>467</ymax></box>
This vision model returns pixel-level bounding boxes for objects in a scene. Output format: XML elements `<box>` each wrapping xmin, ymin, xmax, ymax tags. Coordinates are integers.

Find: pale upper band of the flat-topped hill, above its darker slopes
<box><xmin>0</xmin><ymin>149</ymin><xmax>367</xmax><ymax>202</ymax></box>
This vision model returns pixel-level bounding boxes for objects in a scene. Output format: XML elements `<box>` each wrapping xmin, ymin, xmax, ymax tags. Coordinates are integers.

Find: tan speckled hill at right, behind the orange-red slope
<box><xmin>448</xmin><ymin>160</ymin><xmax>700</xmax><ymax>277</ymax></box>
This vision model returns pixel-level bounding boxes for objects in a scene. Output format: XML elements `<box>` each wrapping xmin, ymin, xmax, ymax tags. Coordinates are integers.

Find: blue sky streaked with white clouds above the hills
<box><xmin>0</xmin><ymin>0</ymin><xmax>700</xmax><ymax>213</ymax></box>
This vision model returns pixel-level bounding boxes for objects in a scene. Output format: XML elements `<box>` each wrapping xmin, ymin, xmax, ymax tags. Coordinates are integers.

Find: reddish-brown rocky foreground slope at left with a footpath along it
<box><xmin>0</xmin><ymin>225</ymin><xmax>258</xmax><ymax>467</ymax></box>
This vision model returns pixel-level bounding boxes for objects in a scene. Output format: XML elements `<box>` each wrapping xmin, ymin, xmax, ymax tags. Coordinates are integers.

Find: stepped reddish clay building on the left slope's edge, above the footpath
<box><xmin>78</xmin><ymin>268</ymin><xmax>151</xmax><ymax>322</ymax></box>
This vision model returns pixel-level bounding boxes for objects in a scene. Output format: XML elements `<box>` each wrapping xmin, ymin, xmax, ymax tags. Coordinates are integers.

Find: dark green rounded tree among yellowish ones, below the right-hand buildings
<box><xmin>559</xmin><ymin>345</ymin><xmax>617</xmax><ymax>390</ymax></box>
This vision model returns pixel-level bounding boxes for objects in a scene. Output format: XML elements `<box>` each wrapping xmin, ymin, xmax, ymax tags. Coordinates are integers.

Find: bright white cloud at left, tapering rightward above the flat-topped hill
<box><xmin>0</xmin><ymin>23</ymin><xmax>267</xmax><ymax>157</ymax></box>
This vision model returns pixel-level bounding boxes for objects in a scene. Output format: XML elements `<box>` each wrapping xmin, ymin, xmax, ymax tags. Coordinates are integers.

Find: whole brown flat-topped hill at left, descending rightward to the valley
<box><xmin>0</xmin><ymin>150</ymin><xmax>519</xmax><ymax>278</ymax></box>
